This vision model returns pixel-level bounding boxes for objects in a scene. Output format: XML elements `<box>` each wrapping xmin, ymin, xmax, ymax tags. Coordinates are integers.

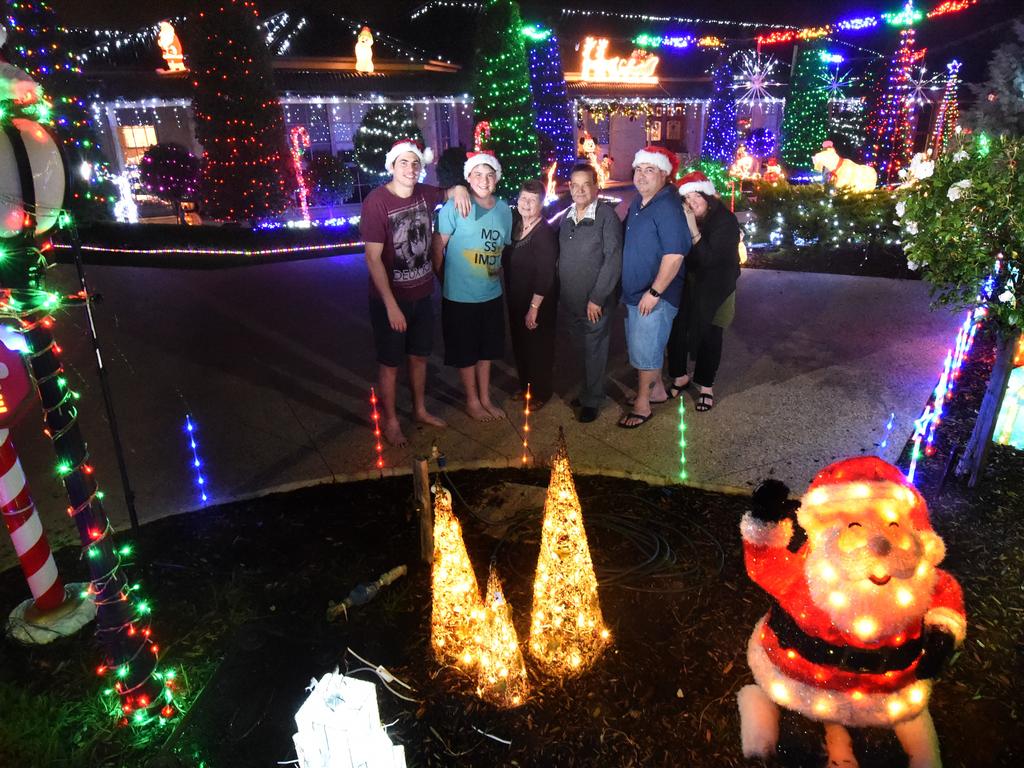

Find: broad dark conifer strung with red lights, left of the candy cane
<box><xmin>189</xmin><ymin>0</ymin><xmax>294</xmax><ymax>221</ymax></box>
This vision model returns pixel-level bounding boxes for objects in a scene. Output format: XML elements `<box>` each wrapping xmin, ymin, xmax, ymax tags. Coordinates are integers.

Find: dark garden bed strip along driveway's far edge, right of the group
<box><xmin>744</xmin><ymin>247</ymin><xmax>921</xmax><ymax>280</ymax></box>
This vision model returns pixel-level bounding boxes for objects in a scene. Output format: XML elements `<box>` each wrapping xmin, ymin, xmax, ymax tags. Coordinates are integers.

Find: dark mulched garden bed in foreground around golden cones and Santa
<box><xmin>0</xmin><ymin>325</ymin><xmax>1024</xmax><ymax>768</ymax></box>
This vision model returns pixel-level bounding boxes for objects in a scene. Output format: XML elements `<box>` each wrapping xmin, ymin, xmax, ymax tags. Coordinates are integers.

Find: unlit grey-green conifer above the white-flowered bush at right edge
<box><xmin>966</xmin><ymin>20</ymin><xmax>1024</xmax><ymax>136</ymax></box>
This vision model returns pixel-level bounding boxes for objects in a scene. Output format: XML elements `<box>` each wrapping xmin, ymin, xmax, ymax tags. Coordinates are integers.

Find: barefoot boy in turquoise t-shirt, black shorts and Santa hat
<box><xmin>433</xmin><ymin>152</ymin><xmax>512</xmax><ymax>421</ymax></box>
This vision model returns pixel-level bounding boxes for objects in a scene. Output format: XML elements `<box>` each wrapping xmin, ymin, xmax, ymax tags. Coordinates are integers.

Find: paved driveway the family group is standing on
<box><xmin>0</xmin><ymin>255</ymin><xmax>958</xmax><ymax>568</ymax></box>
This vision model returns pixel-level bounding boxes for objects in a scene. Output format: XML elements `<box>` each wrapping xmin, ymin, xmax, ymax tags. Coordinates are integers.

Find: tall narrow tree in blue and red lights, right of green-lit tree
<box><xmin>864</xmin><ymin>29</ymin><xmax>915</xmax><ymax>183</ymax></box>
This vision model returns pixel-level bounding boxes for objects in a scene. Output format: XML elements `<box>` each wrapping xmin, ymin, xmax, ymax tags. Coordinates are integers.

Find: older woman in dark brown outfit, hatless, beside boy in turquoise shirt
<box><xmin>502</xmin><ymin>181</ymin><xmax>558</xmax><ymax>411</ymax></box>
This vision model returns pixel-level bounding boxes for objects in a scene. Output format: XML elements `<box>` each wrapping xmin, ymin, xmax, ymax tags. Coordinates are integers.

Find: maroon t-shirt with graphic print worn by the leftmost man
<box><xmin>359</xmin><ymin>184</ymin><xmax>447</xmax><ymax>301</ymax></box>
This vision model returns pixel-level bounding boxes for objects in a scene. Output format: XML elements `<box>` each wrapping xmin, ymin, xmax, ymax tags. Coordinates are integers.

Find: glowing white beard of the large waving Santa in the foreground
<box><xmin>805</xmin><ymin>534</ymin><xmax>936</xmax><ymax>644</ymax></box>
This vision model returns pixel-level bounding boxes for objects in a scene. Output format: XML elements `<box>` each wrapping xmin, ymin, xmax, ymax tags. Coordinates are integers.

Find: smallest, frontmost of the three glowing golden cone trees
<box><xmin>476</xmin><ymin>563</ymin><xmax>529</xmax><ymax>709</ymax></box>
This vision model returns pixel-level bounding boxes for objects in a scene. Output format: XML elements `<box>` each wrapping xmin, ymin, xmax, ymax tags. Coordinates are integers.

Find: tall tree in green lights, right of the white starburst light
<box><xmin>782</xmin><ymin>46</ymin><xmax>828</xmax><ymax>168</ymax></box>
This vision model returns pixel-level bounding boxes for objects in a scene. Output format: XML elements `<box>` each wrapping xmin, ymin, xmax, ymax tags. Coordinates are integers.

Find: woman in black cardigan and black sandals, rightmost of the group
<box><xmin>669</xmin><ymin>185</ymin><xmax>739</xmax><ymax>411</ymax></box>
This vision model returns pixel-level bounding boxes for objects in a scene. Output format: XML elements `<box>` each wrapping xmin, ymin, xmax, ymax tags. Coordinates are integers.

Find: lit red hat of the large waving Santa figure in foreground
<box><xmin>798</xmin><ymin>456</ymin><xmax>938</xmax><ymax>539</ymax></box>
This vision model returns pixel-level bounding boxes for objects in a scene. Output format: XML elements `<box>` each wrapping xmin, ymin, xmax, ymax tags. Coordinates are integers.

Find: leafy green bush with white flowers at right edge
<box><xmin>896</xmin><ymin>134</ymin><xmax>1024</xmax><ymax>331</ymax></box>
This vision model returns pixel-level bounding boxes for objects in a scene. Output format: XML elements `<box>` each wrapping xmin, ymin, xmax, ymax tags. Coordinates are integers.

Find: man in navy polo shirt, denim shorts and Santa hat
<box><xmin>618</xmin><ymin>146</ymin><xmax>690</xmax><ymax>429</ymax></box>
